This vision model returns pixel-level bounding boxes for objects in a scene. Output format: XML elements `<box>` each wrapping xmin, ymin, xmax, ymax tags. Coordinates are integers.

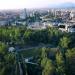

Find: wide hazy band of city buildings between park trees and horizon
<box><xmin>0</xmin><ymin>9</ymin><xmax>75</xmax><ymax>32</ymax></box>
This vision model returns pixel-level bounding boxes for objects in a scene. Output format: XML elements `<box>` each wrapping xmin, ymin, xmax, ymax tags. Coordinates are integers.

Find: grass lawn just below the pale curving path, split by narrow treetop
<box><xmin>19</xmin><ymin>48</ymin><xmax>57</xmax><ymax>58</ymax></box>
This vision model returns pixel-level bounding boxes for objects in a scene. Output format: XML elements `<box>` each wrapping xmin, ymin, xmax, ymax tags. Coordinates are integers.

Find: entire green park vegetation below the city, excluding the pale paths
<box><xmin>0</xmin><ymin>25</ymin><xmax>75</xmax><ymax>75</ymax></box>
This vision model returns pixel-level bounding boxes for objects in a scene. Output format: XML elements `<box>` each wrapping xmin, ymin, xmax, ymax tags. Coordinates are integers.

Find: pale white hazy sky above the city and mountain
<box><xmin>0</xmin><ymin>0</ymin><xmax>75</xmax><ymax>9</ymax></box>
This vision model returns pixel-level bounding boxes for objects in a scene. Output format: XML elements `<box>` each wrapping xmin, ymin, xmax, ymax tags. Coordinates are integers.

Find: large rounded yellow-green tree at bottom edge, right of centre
<box><xmin>41</xmin><ymin>58</ymin><xmax>55</xmax><ymax>75</ymax></box>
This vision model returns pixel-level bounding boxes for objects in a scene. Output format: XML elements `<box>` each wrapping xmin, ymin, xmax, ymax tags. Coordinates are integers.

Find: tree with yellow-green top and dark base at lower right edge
<box><xmin>66</xmin><ymin>48</ymin><xmax>75</xmax><ymax>75</ymax></box>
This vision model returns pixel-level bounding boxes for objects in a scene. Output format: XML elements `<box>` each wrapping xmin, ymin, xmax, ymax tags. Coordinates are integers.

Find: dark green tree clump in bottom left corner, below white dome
<box><xmin>0</xmin><ymin>42</ymin><xmax>15</xmax><ymax>75</ymax></box>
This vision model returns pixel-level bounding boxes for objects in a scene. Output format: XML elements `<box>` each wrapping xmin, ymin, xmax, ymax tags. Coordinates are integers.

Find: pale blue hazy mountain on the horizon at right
<box><xmin>51</xmin><ymin>2</ymin><xmax>75</xmax><ymax>8</ymax></box>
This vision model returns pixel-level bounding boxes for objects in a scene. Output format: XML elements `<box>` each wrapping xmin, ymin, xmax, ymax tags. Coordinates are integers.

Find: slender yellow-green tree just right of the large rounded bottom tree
<box><xmin>56</xmin><ymin>52</ymin><xmax>65</xmax><ymax>75</ymax></box>
